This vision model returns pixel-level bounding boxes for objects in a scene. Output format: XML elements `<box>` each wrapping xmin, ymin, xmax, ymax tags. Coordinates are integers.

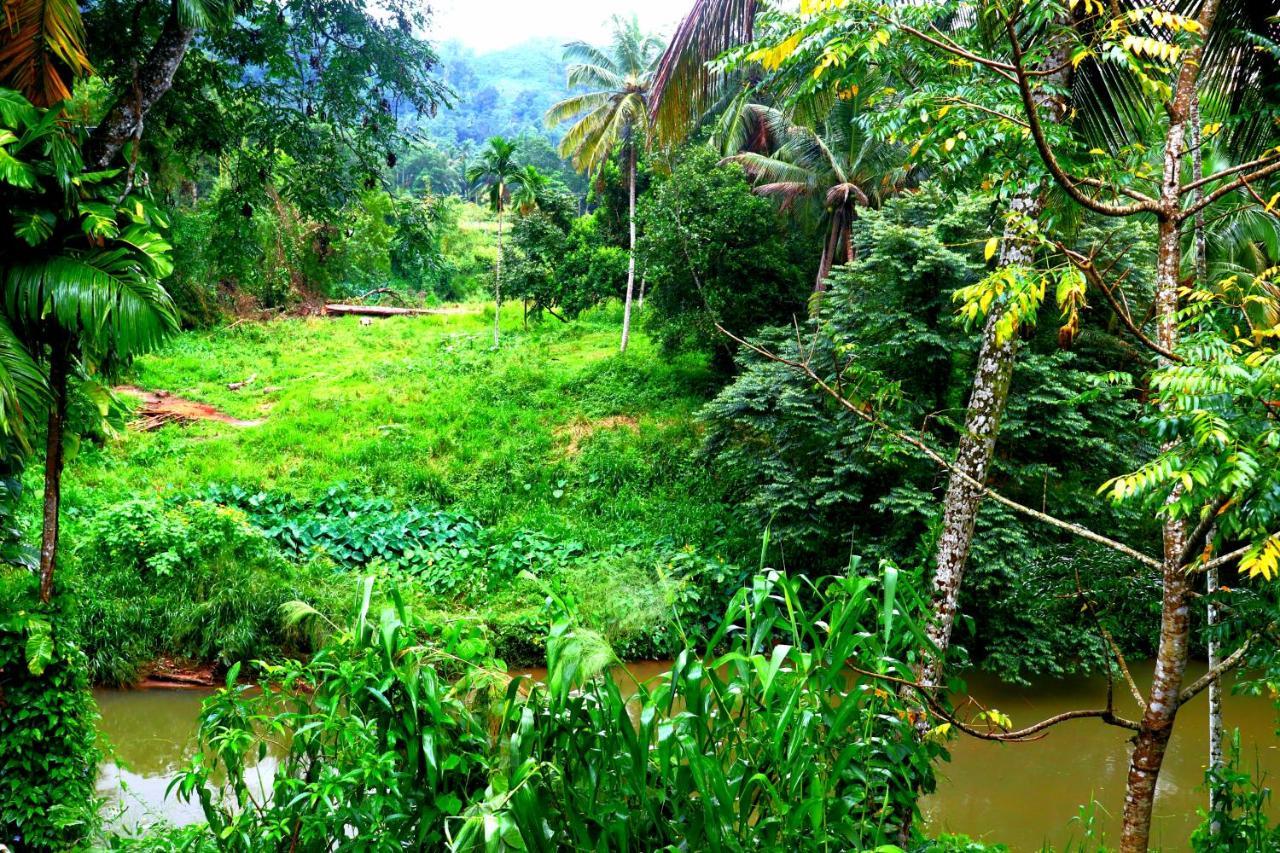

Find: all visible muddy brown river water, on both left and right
<box><xmin>96</xmin><ymin>661</ymin><xmax>1280</xmax><ymax>852</ymax></box>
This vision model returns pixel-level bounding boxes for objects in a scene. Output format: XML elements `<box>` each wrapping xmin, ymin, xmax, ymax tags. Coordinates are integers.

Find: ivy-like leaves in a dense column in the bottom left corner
<box><xmin>0</xmin><ymin>611</ymin><xmax>99</xmax><ymax>852</ymax></box>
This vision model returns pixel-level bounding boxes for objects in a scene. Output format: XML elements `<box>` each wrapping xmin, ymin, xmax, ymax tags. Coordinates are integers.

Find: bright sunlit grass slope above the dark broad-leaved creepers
<box><xmin>64</xmin><ymin>306</ymin><xmax>728</xmax><ymax>547</ymax></box>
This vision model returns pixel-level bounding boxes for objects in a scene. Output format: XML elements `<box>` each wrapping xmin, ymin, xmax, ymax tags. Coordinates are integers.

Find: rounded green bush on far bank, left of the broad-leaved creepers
<box><xmin>64</xmin><ymin>500</ymin><xmax>332</xmax><ymax>684</ymax></box>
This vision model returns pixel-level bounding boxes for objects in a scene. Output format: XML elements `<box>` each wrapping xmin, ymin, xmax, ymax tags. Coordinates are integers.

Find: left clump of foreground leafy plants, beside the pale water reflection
<box><xmin>177</xmin><ymin>578</ymin><xmax>500</xmax><ymax>852</ymax></box>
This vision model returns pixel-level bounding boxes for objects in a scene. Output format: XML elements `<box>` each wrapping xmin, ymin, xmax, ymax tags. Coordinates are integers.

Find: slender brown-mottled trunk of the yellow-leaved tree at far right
<box><xmin>1120</xmin><ymin>8</ymin><xmax>1219</xmax><ymax>853</ymax></box>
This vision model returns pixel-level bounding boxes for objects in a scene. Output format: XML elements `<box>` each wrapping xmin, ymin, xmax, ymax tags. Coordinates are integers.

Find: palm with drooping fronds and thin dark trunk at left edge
<box><xmin>0</xmin><ymin>90</ymin><xmax>178</xmax><ymax>602</ymax></box>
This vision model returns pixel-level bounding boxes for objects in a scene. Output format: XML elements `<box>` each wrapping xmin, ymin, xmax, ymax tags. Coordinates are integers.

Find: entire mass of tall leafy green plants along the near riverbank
<box><xmin>178</xmin><ymin>567</ymin><xmax>952</xmax><ymax>850</ymax></box>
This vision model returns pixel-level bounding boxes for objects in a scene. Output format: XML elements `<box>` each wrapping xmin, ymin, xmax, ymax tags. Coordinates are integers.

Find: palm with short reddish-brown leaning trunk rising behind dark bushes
<box><xmin>727</xmin><ymin>96</ymin><xmax>908</xmax><ymax>292</ymax></box>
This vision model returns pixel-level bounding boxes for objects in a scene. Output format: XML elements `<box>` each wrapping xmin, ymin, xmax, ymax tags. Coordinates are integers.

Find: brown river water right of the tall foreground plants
<box><xmin>923</xmin><ymin>665</ymin><xmax>1280</xmax><ymax>853</ymax></box>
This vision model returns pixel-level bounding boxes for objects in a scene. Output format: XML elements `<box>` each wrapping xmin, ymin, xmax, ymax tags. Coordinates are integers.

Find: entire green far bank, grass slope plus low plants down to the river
<box><xmin>0</xmin><ymin>309</ymin><xmax>765</xmax><ymax>684</ymax></box>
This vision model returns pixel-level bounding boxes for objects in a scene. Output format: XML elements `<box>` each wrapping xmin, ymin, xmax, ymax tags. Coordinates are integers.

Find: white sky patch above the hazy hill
<box><xmin>429</xmin><ymin>0</ymin><xmax>694</xmax><ymax>51</ymax></box>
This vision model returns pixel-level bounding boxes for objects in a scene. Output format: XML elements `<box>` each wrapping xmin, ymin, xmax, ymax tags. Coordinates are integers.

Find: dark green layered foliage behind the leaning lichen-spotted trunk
<box><xmin>703</xmin><ymin>190</ymin><xmax>1155</xmax><ymax>678</ymax></box>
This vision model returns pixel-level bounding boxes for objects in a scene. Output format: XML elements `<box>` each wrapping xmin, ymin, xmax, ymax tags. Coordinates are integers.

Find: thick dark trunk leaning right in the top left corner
<box><xmin>84</xmin><ymin>4</ymin><xmax>196</xmax><ymax>170</ymax></box>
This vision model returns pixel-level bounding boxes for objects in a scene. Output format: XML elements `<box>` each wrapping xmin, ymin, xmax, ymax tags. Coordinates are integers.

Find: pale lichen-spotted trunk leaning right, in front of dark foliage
<box><xmin>919</xmin><ymin>46</ymin><xmax>1070</xmax><ymax>686</ymax></box>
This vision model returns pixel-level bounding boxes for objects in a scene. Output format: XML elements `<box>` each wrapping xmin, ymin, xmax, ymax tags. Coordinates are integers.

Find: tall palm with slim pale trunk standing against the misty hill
<box><xmin>547</xmin><ymin>15</ymin><xmax>662</xmax><ymax>352</ymax></box>
